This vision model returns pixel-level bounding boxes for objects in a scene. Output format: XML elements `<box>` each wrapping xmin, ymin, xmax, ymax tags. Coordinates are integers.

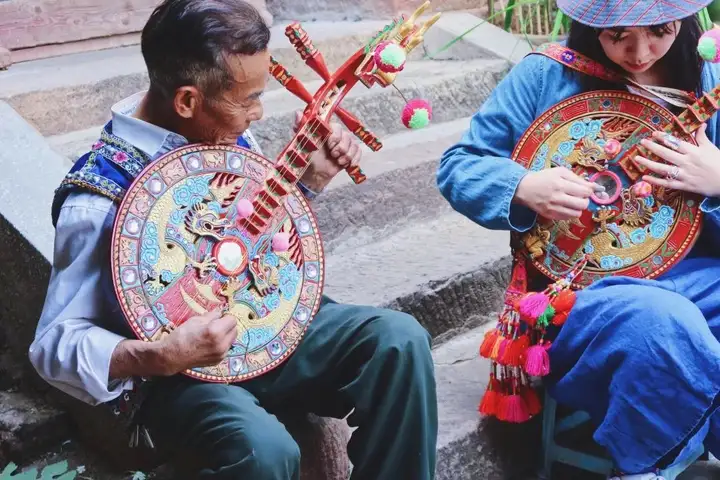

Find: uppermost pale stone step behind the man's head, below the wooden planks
<box><xmin>0</xmin><ymin>14</ymin><xmax>486</xmax><ymax>136</ymax></box>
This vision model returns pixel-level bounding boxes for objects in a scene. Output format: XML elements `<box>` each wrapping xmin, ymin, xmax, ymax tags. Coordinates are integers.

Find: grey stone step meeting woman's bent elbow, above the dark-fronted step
<box><xmin>312</xmin><ymin>118</ymin><xmax>470</xmax><ymax>252</ymax></box>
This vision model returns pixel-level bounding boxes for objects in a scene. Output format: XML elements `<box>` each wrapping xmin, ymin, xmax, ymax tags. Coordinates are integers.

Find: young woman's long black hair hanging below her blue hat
<box><xmin>567</xmin><ymin>15</ymin><xmax>703</xmax><ymax>95</ymax></box>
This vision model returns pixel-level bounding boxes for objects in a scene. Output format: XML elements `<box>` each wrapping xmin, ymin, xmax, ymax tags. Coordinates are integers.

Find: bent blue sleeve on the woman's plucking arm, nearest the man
<box><xmin>437</xmin><ymin>55</ymin><xmax>549</xmax><ymax>232</ymax></box>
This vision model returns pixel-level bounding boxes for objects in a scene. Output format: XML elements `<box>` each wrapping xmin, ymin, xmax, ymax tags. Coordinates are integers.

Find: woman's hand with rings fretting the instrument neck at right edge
<box><xmin>635</xmin><ymin>124</ymin><xmax>720</xmax><ymax>197</ymax></box>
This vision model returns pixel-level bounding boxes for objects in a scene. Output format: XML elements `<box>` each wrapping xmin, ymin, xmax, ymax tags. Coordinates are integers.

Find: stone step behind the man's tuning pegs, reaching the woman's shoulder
<box><xmin>48</xmin><ymin>56</ymin><xmax>507</xmax><ymax>161</ymax></box>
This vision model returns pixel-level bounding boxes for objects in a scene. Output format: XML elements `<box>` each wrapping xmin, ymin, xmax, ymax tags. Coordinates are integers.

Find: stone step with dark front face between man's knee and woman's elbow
<box><xmin>325</xmin><ymin>212</ymin><xmax>510</xmax><ymax>340</ymax></box>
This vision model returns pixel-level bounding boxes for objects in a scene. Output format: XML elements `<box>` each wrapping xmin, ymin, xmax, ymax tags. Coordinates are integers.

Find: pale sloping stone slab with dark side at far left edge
<box><xmin>0</xmin><ymin>101</ymin><xmax>65</xmax><ymax>390</ymax></box>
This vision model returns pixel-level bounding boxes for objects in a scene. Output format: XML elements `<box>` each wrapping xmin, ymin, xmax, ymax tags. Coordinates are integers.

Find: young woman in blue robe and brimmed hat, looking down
<box><xmin>438</xmin><ymin>0</ymin><xmax>720</xmax><ymax>479</ymax></box>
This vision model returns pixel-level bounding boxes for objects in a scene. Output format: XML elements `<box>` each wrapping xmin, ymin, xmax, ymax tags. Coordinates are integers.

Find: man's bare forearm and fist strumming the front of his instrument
<box><xmin>110</xmin><ymin>311</ymin><xmax>237</xmax><ymax>379</ymax></box>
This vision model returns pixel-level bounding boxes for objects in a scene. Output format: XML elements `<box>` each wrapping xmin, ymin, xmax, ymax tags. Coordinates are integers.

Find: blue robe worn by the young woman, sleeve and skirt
<box><xmin>437</xmin><ymin>51</ymin><xmax>720</xmax><ymax>474</ymax></box>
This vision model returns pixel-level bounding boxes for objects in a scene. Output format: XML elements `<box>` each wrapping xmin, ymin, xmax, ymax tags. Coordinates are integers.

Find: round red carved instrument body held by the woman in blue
<box><xmin>513</xmin><ymin>91</ymin><xmax>702</xmax><ymax>287</ymax></box>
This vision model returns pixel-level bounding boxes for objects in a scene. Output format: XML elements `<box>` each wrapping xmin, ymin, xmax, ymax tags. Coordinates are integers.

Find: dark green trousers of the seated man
<box><xmin>141</xmin><ymin>300</ymin><xmax>437</xmax><ymax>480</ymax></box>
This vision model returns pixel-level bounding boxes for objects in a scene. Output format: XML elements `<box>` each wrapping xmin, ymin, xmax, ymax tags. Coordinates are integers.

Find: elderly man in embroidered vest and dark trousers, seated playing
<box><xmin>30</xmin><ymin>0</ymin><xmax>437</xmax><ymax>480</ymax></box>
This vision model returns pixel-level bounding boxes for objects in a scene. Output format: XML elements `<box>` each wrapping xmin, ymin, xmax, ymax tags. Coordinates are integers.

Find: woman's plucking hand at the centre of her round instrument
<box><xmin>515</xmin><ymin>167</ymin><xmax>604</xmax><ymax>220</ymax></box>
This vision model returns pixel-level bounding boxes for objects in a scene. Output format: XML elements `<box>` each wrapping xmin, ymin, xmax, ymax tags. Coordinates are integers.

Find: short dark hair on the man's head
<box><xmin>141</xmin><ymin>0</ymin><xmax>270</xmax><ymax>98</ymax></box>
